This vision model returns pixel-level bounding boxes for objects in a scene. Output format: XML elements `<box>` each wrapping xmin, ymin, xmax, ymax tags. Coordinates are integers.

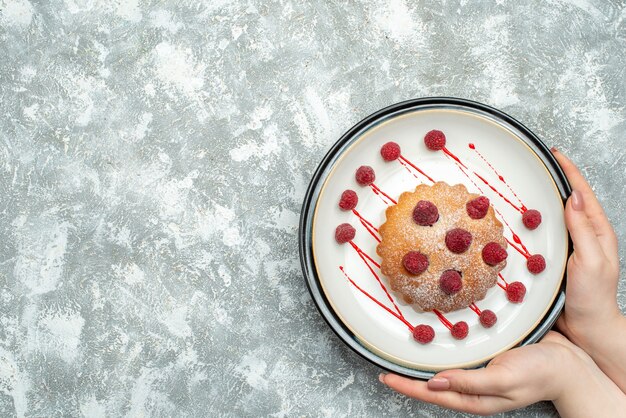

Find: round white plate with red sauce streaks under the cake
<box><xmin>303</xmin><ymin>98</ymin><xmax>569</xmax><ymax>374</ymax></box>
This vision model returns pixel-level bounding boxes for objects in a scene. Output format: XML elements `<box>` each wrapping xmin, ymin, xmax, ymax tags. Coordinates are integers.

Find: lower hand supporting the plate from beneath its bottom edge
<box><xmin>380</xmin><ymin>331</ymin><xmax>626</xmax><ymax>417</ymax></box>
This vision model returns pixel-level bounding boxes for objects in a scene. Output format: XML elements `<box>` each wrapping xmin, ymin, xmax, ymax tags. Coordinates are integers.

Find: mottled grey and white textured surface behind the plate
<box><xmin>0</xmin><ymin>0</ymin><xmax>626</xmax><ymax>417</ymax></box>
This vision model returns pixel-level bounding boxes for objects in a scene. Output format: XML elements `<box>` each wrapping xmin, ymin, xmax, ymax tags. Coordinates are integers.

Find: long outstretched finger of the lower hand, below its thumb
<box><xmin>381</xmin><ymin>373</ymin><xmax>514</xmax><ymax>414</ymax></box>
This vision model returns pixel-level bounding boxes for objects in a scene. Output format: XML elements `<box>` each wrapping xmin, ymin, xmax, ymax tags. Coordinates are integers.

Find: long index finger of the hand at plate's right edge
<box><xmin>552</xmin><ymin>148</ymin><xmax>617</xmax><ymax>252</ymax></box>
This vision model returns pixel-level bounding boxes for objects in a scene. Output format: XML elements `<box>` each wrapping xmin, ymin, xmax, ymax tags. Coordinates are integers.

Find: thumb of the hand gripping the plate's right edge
<box><xmin>565</xmin><ymin>190</ymin><xmax>603</xmax><ymax>258</ymax></box>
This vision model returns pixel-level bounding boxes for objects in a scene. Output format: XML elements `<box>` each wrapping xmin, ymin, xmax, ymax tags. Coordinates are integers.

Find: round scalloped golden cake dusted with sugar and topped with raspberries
<box><xmin>376</xmin><ymin>182</ymin><xmax>507</xmax><ymax>312</ymax></box>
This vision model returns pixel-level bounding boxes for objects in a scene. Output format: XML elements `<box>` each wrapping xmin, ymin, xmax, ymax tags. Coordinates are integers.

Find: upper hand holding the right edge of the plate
<box><xmin>552</xmin><ymin>149</ymin><xmax>626</xmax><ymax>357</ymax></box>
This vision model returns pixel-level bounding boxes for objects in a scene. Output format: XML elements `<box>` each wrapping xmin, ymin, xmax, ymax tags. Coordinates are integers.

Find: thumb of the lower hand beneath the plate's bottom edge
<box><xmin>428</xmin><ymin>365</ymin><xmax>509</xmax><ymax>395</ymax></box>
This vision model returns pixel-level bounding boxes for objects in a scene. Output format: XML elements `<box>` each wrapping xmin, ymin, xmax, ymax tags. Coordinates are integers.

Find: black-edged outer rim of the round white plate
<box><xmin>298</xmin><ymin>96</ymin><xmax>572</xmax><ymax>379</ymax></box>
